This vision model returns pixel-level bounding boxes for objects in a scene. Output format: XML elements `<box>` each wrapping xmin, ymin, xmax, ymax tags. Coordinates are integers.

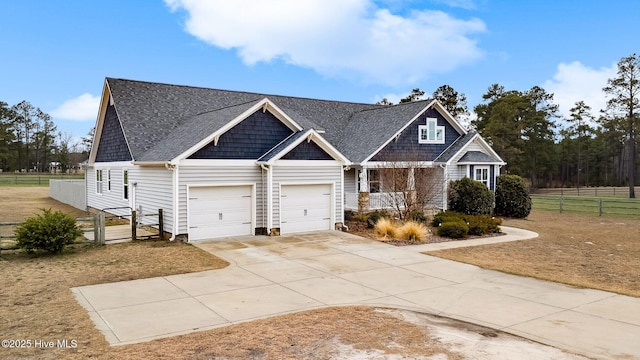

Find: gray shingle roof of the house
<box><xmin>107</xmin><ymin>78</ymin><xmax>480</xmax><ymax>163</ymax></box>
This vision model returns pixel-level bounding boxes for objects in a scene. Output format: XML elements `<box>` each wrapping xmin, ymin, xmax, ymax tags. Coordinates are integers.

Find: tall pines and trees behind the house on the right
<box><xmin>378</xmin><ymin>54</ymin><xmax>640</xmax><ymax>198</ymax></box>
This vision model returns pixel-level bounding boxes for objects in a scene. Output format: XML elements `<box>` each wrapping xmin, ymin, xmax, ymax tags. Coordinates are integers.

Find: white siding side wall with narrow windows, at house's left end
<box><xmin>85</xmin><ymin>163</ymin><xmax>131</xmax><ymax>216</ymax></box>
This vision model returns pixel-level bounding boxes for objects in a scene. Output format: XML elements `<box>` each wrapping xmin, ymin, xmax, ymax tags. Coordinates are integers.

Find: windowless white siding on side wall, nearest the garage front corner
<box><xmin>129</xmin><ymin>166</ymin><xmax>173</xmax><ymax>232</ymax></box>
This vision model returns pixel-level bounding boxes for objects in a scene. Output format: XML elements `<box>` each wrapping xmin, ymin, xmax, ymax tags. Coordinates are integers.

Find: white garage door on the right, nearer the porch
<box><xmin>280</xmin><ymin>184</ymin><xmax>332</xmax><ymax>234</ymax></box>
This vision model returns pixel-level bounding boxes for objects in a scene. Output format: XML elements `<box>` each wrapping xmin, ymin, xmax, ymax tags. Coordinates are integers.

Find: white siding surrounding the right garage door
<box><xmin>272</xmin><ymin>164</ymin><xmax>344</xmax><ymax>228</ymax></box>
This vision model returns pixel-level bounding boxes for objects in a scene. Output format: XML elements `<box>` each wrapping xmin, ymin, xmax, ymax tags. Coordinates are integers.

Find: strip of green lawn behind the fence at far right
<box><xmin>531</xmin><ymin>195</ymin><xmax>640</xmax><ymax>218</ymax></box>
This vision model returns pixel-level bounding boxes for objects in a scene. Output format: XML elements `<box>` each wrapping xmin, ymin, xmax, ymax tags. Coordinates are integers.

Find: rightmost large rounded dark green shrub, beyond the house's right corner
<box><xmin>495</xmin><ymin>175</ymin><xmax>531</xmax><ymax>219</ymax></box>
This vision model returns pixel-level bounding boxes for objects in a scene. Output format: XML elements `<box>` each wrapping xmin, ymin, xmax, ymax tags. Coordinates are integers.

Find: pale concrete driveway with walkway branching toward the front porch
<box><xmin>72</xmin><ymin>228</ymin><xmax>640</xmax><ymax>359</ymax></box>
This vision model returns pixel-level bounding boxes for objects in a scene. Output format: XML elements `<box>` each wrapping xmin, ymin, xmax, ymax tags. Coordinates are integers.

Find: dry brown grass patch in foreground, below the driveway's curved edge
<box><xmin>97</xmin><ymin>307</ymin><xmax>464</xmax><ymax>360</ymax></box>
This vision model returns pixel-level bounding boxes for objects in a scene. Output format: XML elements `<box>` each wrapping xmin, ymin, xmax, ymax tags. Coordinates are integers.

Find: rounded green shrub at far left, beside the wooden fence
<box><xmin>15</xmin><ymin>209</ymin><xmax>82</xmax><ymax>253</ymax></box>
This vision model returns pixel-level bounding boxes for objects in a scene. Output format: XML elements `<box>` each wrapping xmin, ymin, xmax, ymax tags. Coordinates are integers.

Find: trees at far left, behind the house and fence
<box><xmin>0</xmin><ymin>100</ymin><xmax>91</xmax><ymax>172</ymax></box>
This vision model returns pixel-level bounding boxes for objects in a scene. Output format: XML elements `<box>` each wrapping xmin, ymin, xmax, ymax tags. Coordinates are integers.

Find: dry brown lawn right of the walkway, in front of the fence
<box><xmin>429</xmin><ymin>211</ymin><xmax>640</xmax><ymax>297</ymax></box>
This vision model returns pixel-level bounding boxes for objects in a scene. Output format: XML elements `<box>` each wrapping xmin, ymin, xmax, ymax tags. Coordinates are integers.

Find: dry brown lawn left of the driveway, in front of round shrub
<box><xmin>0</xmin><ymin>241</ymin><xmax>228</xmax><ymax>358</ymax></box>
